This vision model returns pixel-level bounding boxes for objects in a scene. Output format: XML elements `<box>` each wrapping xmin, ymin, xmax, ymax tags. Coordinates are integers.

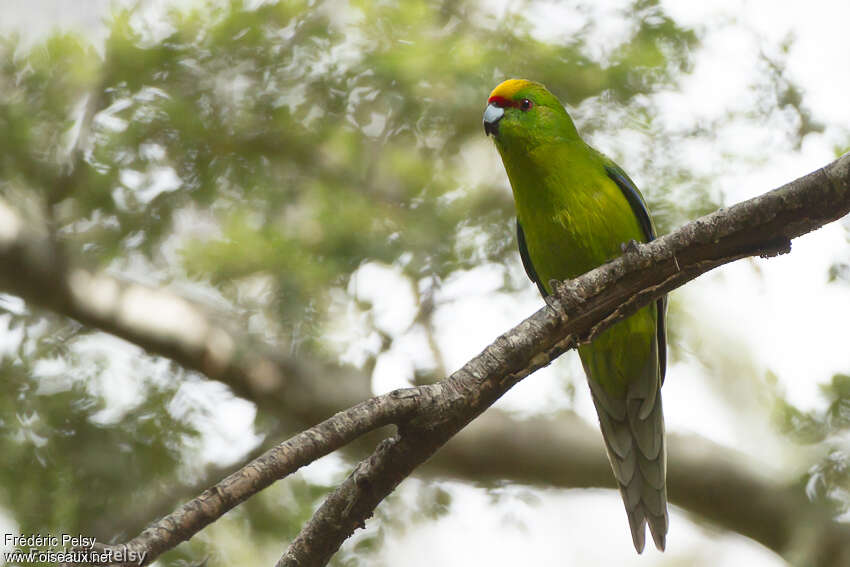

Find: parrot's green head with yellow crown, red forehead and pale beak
<box><xmin>484</xmin><ymin>79</ymin><xmax>578</xmax><ymax>150</ymax></box>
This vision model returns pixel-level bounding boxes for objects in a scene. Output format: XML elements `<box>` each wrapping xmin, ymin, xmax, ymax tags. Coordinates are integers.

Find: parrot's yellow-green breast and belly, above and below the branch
<box><xmin>499</xmin><ymin>140</ymin><xmax>657</xmax><ymax>397</ymax></box>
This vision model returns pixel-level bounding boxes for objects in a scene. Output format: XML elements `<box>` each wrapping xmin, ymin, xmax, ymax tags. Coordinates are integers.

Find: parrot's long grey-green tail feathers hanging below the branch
<box><xmin>588</xmin><ymin>344</ymin><xmax>668</xmax><ymax>553</ymax></box>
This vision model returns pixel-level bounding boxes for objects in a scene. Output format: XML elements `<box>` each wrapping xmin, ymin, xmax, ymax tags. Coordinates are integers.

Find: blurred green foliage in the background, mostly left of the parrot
<box><xmin>0</xmin><ymin>0</ymin><xmax>846</xmax><ymax>565</ymax></box>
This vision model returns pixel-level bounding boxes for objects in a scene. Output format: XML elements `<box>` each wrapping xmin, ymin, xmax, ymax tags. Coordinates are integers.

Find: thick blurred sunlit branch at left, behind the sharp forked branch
<box><xmin>0</xmin><ymin>199</ymin><xmax>370</xmax><ymax>429</ymax></box>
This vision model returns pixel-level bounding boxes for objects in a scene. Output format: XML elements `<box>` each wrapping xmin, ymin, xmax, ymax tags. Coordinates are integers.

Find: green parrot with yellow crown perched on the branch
<box><xmin>484</xmin><ymin>79</ymin><xmax>668</xmax><ymax>553</ymax></box>
